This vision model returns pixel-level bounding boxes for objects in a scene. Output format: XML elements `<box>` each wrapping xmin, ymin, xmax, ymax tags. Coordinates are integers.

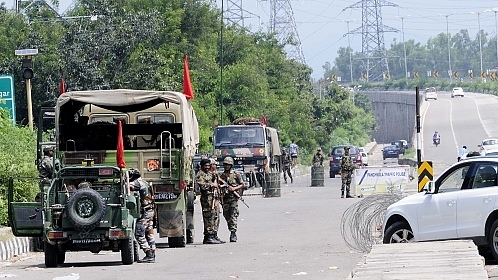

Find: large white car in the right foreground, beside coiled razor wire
<box><xmin>383</xmin><ymin>157</ymin><xmax>498</xmax><ymax>260</ymax></box>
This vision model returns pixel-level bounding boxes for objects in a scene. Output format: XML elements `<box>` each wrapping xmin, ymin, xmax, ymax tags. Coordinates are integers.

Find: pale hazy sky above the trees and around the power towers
<box><xmin>10</xmin><ymin>0</ymin><xmax>498</xmax><ymax>79</ymax></box>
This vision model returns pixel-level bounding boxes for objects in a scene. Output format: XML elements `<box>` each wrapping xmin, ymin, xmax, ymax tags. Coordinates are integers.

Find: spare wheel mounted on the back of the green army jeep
<box><xmin>66</xmin><ymin>188</ymin><xmax>106</xmax><ymax>230</ymax></box>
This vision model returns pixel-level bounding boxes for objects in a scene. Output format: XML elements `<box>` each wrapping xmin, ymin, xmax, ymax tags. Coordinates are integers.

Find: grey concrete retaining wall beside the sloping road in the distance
<box><xmin>363</xmin><ymin>90</ymin><xmax>416</xmax><ymax>143</ymax></box>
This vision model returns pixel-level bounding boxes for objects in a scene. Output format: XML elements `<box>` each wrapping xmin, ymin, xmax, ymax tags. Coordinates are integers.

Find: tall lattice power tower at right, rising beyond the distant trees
<box><xmin>342</xmin><ymin>0</ymin><xmax>398</xmax><ymax>81</ymax></box>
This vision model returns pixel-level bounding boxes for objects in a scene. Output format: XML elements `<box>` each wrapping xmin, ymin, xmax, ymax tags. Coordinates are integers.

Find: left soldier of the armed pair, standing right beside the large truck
<box><xmin>195</xmin><ymin>158</ymin><xmax>222</xmax><ymax>244</ymax></box>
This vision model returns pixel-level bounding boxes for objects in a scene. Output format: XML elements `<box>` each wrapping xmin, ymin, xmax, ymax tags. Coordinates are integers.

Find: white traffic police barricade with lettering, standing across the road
<box><xmin>354</xmin><ymin>165</ymin><xmax>410</xmax><ymax>195</ymax></box>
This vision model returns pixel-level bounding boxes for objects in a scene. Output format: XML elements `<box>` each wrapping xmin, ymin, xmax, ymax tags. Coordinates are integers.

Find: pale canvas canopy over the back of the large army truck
<box><xmin>55</xmin><ymin>89</ymin><xmax>199</xmax><ymax>158</ymax></box>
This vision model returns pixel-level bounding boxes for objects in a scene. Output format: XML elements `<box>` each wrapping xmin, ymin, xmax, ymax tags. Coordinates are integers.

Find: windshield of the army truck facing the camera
<box><xmin>214</xmin><ymin>126</ymin><xmax>265</xmax><ymax>147</ymax></box>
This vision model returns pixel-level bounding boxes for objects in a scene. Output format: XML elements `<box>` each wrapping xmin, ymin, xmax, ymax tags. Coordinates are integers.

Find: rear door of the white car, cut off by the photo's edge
<box><xmin>457</xmin><ymin>162</ymin><xmax>498</xmax><ymax>238</ymax></box>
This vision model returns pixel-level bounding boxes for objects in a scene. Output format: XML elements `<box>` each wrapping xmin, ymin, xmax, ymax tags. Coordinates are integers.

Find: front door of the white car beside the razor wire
<box><xmin>417</xmin><ymin>162</ymin><xmax>471</xmax><ymax>241</ymax></box>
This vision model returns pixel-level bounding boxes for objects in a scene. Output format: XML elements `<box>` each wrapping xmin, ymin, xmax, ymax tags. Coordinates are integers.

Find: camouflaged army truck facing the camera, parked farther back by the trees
<box><xmin>212</xmin><ymin>117</ymin><xmax>281</xmax><ymax>191</ymax></box>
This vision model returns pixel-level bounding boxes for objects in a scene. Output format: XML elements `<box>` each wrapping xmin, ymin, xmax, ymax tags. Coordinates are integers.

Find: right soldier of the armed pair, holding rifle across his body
<box><xmin>219</xmin><ymin>157</ymin><xmax>244</xmax><ymax>242</ymax></box>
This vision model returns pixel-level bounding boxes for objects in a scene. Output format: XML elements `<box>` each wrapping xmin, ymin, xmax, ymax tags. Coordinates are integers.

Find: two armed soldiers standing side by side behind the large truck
<box><xmin>196</xmin><ymin>157</ymin><xmax>244</xmax><ymax>244</ymax></box>
